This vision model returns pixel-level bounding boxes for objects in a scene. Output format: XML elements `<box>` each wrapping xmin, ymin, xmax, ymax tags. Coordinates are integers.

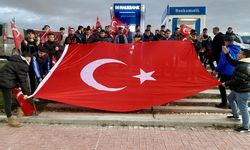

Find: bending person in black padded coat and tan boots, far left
<box><xmin>0</xmin><ymin>53</ymin><xmax>31</xmax><ymax>127</ymax></box>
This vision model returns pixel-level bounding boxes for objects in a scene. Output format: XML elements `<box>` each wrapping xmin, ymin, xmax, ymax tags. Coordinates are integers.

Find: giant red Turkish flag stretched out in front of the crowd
<box><xmin>32</xmin><ymin>41</ymin><xmax>220</xmax><ymax>112</ymax></box>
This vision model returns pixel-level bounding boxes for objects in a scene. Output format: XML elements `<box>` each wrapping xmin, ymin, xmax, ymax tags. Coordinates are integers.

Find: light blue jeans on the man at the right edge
<box><xmin>227</xmin><ymin>91</ymin><xmax>250</xmax><ymax>129</ymax></box>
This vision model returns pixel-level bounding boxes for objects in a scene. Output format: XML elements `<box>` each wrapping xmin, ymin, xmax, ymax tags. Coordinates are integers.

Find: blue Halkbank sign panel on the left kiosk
<box><xmin>114</xmin><ymin>3</ymin><xmax>141</xmax><ymax>25</ymax></box>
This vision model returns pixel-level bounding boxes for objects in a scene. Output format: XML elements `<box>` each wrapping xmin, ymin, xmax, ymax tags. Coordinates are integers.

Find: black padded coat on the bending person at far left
<box><xmin>0</xmin><ymin>55</ymin><xmax>30</xmax><ymax>95</ymax></box>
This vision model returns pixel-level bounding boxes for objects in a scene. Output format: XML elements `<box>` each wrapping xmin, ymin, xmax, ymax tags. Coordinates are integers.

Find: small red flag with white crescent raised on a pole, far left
<box><xmin>10</xmin><ymin>21</ymin><xmax>23</xmax><ymax>51</ymax></box>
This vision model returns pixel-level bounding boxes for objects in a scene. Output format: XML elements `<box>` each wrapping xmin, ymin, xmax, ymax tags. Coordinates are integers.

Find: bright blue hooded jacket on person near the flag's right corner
<box><xmin>215</xmin><ymin>44</ymin><xmax>240</xmax><ymax>76</ymax></box>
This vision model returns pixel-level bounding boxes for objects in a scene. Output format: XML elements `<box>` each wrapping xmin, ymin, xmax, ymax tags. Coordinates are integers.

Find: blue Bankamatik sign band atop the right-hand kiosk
<box><xmin>167</xmin><ymin>6</ymin><xmax>206</xmax><ymax>15</ymax></box>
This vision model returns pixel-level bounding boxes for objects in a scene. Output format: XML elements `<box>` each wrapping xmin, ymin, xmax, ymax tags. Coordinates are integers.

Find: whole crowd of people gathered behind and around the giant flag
<box><xmin>0</xmin><ymin>25</ymin><xmax>250</xmax><ymax>132</ymax></box>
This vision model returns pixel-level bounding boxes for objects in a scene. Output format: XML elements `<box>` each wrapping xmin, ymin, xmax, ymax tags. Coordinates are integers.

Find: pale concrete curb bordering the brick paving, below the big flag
<box><xmin>0</xmin><ymin>112</ymin><xmax>241</xmax><ymax>128</ymax></box>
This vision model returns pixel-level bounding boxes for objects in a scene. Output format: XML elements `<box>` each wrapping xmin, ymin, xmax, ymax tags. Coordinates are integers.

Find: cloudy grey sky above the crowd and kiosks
<box><xmin>0</xmin><ymin>0</ymin><xmax>250</xmax><ymax>33</ymax></box>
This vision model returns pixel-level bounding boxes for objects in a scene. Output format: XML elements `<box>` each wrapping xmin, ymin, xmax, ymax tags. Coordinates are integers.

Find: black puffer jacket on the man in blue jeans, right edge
<box><xmin>225</xmin><ymin>54</ymin><xmax>250</xmax><ymax>93</ymax></box>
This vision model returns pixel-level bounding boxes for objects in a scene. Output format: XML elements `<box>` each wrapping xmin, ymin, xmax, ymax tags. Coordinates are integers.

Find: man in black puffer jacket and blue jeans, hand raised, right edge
<box><xmin>222</xmin><ymin>47</ymin><xmax>250</xmax><ymax>132</ymax></box>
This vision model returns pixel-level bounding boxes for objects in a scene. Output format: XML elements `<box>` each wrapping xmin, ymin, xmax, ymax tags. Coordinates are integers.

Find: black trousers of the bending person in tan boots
<box><xmin>2</xmin><ymin>88</ymin><xmax>12</xmax><ymax>118</ymax></box>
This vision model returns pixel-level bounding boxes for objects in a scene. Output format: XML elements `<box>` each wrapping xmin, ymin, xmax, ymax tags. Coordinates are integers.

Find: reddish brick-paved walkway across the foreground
<box><xmin>0</xmin><ymin>124</ymin><xmax>250</xmax><ymax>150</ymax></box>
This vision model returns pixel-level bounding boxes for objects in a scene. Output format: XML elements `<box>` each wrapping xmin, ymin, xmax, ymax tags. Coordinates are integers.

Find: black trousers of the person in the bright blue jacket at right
<box><xmin>219</xmin><ymin>74</ymin><xmax>231</xmax><ymax>105</ymax></box>
